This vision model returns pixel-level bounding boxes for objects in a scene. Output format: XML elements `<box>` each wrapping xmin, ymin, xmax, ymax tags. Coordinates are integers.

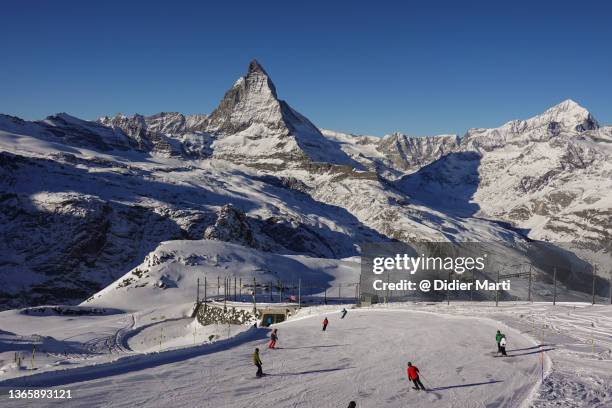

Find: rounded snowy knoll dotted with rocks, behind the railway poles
<box><xmin>82</xmin><ymin>240</ymin><xmax>360</xmax><ymax>311</ymax></box>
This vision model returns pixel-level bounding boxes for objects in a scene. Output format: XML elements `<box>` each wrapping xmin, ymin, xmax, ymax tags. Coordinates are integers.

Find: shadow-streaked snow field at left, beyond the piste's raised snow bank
<box><xmin>0</xmin><ymin>303</ymin><xmax>248</xmax><ymax>381</ymax></box>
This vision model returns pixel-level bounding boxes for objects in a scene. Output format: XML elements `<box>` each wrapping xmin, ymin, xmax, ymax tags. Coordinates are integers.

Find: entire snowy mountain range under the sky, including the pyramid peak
<box><xmin>0</xmin><ymin>61</ymin><xmax>612</xmax><ymax>307</ymax></box>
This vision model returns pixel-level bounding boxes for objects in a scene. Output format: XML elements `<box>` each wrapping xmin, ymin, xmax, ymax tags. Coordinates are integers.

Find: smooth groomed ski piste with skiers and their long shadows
<box><xmin>3</xmin><ymin>309</ymin><xmax>541</xmax><ymax>408</ymax></box>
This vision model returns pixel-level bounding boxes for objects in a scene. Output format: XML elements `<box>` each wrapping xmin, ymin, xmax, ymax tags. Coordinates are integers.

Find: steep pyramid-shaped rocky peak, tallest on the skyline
<box><xmin>207</xmin><ymin>60</ymin><xmax>357</xmax><ymax>166</ymax></box>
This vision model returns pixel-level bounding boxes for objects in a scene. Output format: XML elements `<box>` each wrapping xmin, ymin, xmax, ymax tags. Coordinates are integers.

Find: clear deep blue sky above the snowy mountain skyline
<box><xmin>0</xmin><ymin>0</ymin><xmax>612</xmax><ymax>135</ymax></box>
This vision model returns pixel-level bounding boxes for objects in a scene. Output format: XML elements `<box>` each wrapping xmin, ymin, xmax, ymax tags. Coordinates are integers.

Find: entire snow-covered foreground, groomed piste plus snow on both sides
<box><xmin>0</xmin><ymin>302</ymin><xmax>612</xmax><ymax>408</ymax></box>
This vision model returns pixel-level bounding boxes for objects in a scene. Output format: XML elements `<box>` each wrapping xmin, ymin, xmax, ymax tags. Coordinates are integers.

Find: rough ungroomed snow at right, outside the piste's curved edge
<box><xmin>406</xmin><ymin>303</ymin><xmax>612</xmax><ymax>408</ymax></box>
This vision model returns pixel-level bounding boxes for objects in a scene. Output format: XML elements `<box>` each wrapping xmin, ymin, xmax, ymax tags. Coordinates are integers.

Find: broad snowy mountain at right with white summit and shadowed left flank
<box><xmin>398</xmin><ymin>100</ymin><xmax>612</xmax><ymax>253</ymax></box>
